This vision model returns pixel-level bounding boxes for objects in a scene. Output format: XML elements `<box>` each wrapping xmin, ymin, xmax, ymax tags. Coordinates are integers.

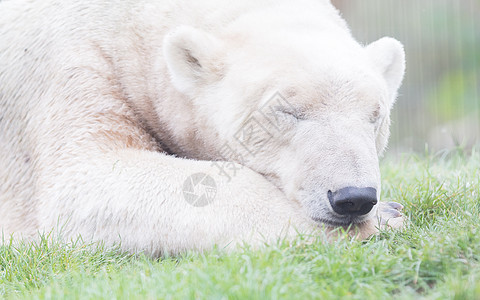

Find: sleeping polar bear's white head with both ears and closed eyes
<box><xmin>163</xmin><ymin>14</ymin><xmax>405</xmax><ymax>225</ymax></box>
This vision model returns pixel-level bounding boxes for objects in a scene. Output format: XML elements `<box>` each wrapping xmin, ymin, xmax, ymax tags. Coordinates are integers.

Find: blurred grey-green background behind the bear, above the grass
<box><xmin>332</xmin><ymin>0</ymin><xmax>480</xmax><ymax>154</ymax></box>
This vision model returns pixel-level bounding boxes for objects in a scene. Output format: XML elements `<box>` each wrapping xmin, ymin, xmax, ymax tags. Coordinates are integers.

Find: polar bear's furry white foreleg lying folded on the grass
<box><xmin>34</xmin><ymin>150</ymin><xmax>317</xmax><ymax>255</ymax></box>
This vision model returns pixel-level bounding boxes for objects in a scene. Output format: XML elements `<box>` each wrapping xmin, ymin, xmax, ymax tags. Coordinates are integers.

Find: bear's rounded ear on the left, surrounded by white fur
<box><xmin>163</xmin><ymin>26</ymin><xmax>222</xmax><ymax>95</ymax></box>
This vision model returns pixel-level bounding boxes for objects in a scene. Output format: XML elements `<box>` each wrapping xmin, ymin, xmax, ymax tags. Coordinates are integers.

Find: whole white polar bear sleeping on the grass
<box><xmin>0</xmin><ymin>0</ymin><xmax>405</xmax><ymax>255</ymax></box>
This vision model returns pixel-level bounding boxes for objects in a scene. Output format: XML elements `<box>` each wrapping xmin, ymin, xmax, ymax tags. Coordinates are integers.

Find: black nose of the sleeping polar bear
<box><xmin>328</xmin><ymin>186</ymin><xmax>377</xmax><ymax>216</ymax></box>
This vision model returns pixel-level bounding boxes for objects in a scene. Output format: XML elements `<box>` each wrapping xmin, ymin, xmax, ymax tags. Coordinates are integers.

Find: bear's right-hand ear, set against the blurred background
<box><xmin>366</xmin><ymin>37</ymin><xmax>405</xmax><ymax>105</ymax></box>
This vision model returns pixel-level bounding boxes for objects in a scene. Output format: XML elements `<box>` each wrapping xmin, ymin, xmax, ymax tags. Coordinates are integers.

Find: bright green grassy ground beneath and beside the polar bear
<box><xmin>0</xmin><ymin>151</ymin><xmax>480</xmax><ymax>299</ymax></box>
